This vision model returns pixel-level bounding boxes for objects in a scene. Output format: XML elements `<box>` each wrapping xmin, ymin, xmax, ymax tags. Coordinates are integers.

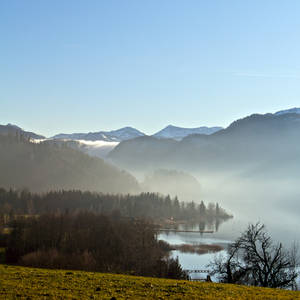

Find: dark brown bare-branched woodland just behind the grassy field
<box><xmin>6</xmin><ymin>212</ymin><xmax>187</xmax><ymax>279</ymax></box>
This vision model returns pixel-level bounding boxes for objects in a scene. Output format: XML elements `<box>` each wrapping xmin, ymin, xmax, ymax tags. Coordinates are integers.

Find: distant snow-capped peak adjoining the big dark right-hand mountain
<box><xmin>153</xmin><ymin>125</ymin><xmax>223</xmax><ymax>140</ymax></box>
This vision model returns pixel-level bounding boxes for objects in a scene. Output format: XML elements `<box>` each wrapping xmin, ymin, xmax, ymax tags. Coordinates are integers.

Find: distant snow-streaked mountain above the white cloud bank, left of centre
<box><xmin>52</xmin><ymin>127</ymin><xmax>145</xmax><ymax>142</ymax></box>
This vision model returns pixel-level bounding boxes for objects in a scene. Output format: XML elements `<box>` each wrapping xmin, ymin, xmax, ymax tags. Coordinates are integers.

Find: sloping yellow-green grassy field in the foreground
<box><xmin>0</xmin><ymin>265</ymin><xmax>300</xmax><ymax>300</ymax></box>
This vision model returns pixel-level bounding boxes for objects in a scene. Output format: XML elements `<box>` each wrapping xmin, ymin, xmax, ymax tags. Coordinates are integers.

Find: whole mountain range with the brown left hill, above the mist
<box><xmin>0</xmin><ymin>108</ymin><xmax>300</xmax><ymax>192</ymax></box>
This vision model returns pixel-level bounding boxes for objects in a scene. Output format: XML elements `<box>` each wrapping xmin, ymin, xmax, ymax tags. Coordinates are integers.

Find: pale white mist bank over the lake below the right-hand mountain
<box><xmin>121</xmin><ymin>164</ymin><xmax>300</xmax><ymax>246</ymax></box>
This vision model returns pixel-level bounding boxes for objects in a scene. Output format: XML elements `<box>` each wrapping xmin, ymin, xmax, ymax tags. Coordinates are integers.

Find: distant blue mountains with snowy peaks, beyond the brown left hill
<box><xmin>0</xmin><ymin>108</ymin><xmax>300</xmax><ymax>168</ymax></box>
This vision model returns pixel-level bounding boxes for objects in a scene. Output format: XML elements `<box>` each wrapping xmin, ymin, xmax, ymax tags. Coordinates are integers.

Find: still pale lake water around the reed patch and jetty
<box><xmin>158</xmin><ymin>214</ymin><xmax>300</xmax><ymax>280</ymax></box>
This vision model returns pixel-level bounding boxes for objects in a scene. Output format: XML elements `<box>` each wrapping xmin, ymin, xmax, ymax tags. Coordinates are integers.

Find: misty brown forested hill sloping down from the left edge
<box><xmin>0</xmin><ymin>135</ymin><xmax>139</xmax><ymax>192</ymax></box>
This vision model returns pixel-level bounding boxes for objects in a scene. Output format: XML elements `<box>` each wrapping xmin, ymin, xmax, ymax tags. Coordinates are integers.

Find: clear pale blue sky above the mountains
<box><xmin>0</xmin><ymin>0</ymin><xmax>300</xmax><ymax>136</ymax></box>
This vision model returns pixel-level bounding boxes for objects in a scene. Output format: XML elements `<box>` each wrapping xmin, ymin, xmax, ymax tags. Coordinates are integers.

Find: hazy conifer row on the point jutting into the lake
<box><xmin>0</xmin><ymin>189</ymin><xmax>230</xmax><ymax>222</ymax></box>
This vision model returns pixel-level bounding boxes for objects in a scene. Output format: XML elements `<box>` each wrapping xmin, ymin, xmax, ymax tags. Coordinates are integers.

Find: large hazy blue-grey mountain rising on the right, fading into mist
<box><xmin>109</xmin><ymin>114</ymin><xmax>300</xmax><ymax>171</ymax></box>
